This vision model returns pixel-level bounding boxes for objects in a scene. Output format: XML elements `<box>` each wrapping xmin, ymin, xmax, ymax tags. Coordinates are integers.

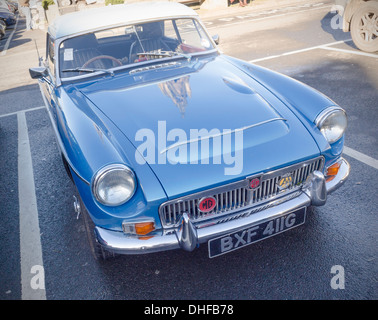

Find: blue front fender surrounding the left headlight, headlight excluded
<box><xmin>52</xmin><ymin>86</ymin><xmax>166</xmax><ymax>231</ymax></box>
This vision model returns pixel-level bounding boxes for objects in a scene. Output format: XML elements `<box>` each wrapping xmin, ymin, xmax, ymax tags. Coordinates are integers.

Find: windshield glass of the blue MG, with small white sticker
<box><xmin>59</xmin><ymin>19</ymin><xmax>214</xmax><ymax>78</ymax></box>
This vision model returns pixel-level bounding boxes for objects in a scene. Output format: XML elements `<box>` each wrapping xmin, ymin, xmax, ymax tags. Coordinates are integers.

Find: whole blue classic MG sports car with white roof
<box><xmin>30</xmin><ymin>2</ymin><xmax>349</xmax><ymax>258</ymax></box>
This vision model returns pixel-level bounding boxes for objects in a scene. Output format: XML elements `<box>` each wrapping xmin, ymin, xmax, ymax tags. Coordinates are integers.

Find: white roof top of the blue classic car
<box><xmin>48</xmin><ymin>2</ymin><xmax>198</xmax><ymax>39</ymax></box>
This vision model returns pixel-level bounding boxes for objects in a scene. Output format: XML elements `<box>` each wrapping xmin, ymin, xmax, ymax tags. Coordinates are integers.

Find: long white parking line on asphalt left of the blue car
<box><xmin>17</xmin><ymin>112</ymin><xmax>46</xmax><ymax>300</ymax></box>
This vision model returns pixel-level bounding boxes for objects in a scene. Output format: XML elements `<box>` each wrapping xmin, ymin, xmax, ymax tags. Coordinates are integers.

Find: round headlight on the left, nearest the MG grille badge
<box><xmin>92</xmin><ymin>164</ymin><xmax>136</xmax><ymax>206</ymax></box>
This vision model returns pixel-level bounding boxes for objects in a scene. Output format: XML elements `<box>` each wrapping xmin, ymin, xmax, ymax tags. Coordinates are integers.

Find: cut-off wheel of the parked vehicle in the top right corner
<box><xmin>350</xmin><ymin>1</ymin><xmax>378</xmax><ymax>52</ymax></box>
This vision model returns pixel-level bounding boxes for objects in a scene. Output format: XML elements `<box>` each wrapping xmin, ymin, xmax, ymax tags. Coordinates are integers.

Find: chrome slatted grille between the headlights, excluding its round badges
<box><xmin>159</xmin><ymin>157</ymin><xmax>324</xmax><ymax>228</ymax></box>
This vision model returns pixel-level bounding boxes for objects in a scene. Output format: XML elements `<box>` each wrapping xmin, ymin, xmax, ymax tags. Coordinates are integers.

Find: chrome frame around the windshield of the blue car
<box><xmin>55</xmin><ymin>16</ymin><xmax>220</xmax><ymax>87</ymax></box>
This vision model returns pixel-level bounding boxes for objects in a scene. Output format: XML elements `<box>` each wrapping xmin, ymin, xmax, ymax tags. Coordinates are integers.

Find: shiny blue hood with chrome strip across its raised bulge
<box><xmin>77</xmin><ymin>56</ymin><xmax>319</xmax><ymax>198</ymax></box>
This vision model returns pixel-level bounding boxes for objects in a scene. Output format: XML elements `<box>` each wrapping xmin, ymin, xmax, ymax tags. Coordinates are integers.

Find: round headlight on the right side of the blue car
<box><xmin>316</xmin><ymin>107</ymin><xmax>348</xmax><ymax>143</ymax></box>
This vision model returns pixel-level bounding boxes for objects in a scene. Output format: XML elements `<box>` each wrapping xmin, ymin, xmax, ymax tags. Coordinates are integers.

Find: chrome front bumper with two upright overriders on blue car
<box><xmin>95</xmin><ymin>158</ymin><xmax>350</xmax><ymax>254</ymax></box>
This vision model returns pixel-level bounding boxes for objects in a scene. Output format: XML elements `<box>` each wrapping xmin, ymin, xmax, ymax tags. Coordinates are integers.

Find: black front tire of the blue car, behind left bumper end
<box><xmin>78</xmin><ymin>196</ymin><xmax>116</xmax><ymax>261</ymax></box>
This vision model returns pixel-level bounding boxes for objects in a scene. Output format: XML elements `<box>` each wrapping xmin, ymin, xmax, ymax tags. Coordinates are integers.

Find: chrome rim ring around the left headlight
<box><xmin>91</xmin><ymin>163</ymin><xmax>137</xmax><ymax>207</ymax></box>
